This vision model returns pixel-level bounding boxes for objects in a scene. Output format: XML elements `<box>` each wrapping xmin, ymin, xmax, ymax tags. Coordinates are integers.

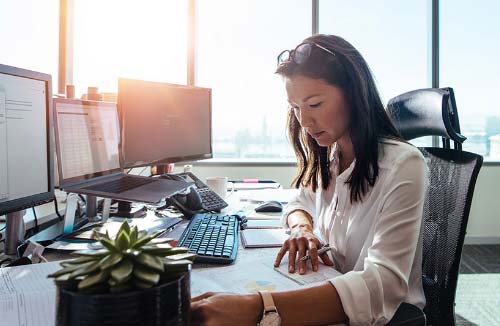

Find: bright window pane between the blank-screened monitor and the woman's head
<box><xmin>196</xmin><ymin>0</ymin><xmax>312</xmax><ymax>160</ymax></box>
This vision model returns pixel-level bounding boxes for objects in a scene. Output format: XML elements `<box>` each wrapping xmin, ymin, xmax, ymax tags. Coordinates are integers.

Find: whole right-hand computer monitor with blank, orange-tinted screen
<box><xmin>118</xmin><ymin>78</ymin><xmax>212</xmax><ymax>168</ymax></box>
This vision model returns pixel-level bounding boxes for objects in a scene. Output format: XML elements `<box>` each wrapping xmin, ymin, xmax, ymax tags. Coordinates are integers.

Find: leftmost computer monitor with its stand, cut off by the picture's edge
<box><xmin>0</xmin><ymin>61</ymin><xmax>54</xmax><ymax>254</ymax></box>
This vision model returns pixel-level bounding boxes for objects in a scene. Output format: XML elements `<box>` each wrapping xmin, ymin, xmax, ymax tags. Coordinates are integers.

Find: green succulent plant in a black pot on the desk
<box><xmin>49</xmin><ymin>222</ymin><xmax>195</xmax><ymax>326</ymax></box>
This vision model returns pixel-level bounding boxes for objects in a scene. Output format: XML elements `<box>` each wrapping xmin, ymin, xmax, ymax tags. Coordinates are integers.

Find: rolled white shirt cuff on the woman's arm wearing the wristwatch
<box><xmin>330</xmin><ymin>272</ymin><xmax>373</xmax><ymax>326</ymax></box>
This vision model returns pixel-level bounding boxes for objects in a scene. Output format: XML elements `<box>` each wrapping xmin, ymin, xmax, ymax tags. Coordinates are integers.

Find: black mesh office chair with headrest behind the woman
<box><xmin>387</xmin><ymin>88</ymin><xmax>483</xmax><ymax>326</ymax></box>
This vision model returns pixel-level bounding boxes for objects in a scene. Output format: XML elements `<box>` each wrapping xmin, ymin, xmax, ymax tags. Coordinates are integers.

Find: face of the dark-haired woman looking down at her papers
<box><xmin>285</xmin><ymin>75</ymin><xmax>350</xmax><ymax>146</ymax></box>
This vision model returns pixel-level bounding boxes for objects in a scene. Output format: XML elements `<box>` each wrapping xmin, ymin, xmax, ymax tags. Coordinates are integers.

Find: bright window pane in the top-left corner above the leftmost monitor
<box><xmin>0</xmin><ymin>0</ymin><xmax>59</xmax><ymax>92</ymax></box>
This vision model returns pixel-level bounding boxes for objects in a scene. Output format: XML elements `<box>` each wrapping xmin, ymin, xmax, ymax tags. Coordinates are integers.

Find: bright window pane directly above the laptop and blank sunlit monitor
<box><xmin>73</xmin><ymin>0</ymin><xmax>187</xmax><ymax>96</ymax></box>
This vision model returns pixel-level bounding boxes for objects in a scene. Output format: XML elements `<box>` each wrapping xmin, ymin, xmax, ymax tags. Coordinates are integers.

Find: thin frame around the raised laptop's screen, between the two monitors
<box><xmin>53</xmin><ymin>98</ymin><xmax>123</xmax><ymax>189</ymax></box>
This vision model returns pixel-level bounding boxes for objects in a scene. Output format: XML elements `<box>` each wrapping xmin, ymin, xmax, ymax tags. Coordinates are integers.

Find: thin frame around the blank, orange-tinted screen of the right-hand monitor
<box><xmin>117</xmin><ymin>78</ymin><xmax>213</xmax><ymax>169</ymax></box>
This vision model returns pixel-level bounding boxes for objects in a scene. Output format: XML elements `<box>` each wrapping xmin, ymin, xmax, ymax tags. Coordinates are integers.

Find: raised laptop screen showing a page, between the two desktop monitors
<box><xmin>54</xmin><ymin>99</ymin><xmax>121</xmax><ymax>188</ymax></box>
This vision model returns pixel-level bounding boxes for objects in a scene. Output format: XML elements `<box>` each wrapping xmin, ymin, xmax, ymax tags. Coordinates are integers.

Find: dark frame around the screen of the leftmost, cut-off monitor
<box><xmin>0</xmin><ymin>64</ymin><xmax>55</xmax><ymax>215</ymax></box>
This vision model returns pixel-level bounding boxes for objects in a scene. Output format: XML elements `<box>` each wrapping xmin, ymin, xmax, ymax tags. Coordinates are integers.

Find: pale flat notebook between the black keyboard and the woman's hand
<box><xmin>241</xmin><ymin>229</ymin><xmax>288</xmax><ymax>248</ymax></box>
